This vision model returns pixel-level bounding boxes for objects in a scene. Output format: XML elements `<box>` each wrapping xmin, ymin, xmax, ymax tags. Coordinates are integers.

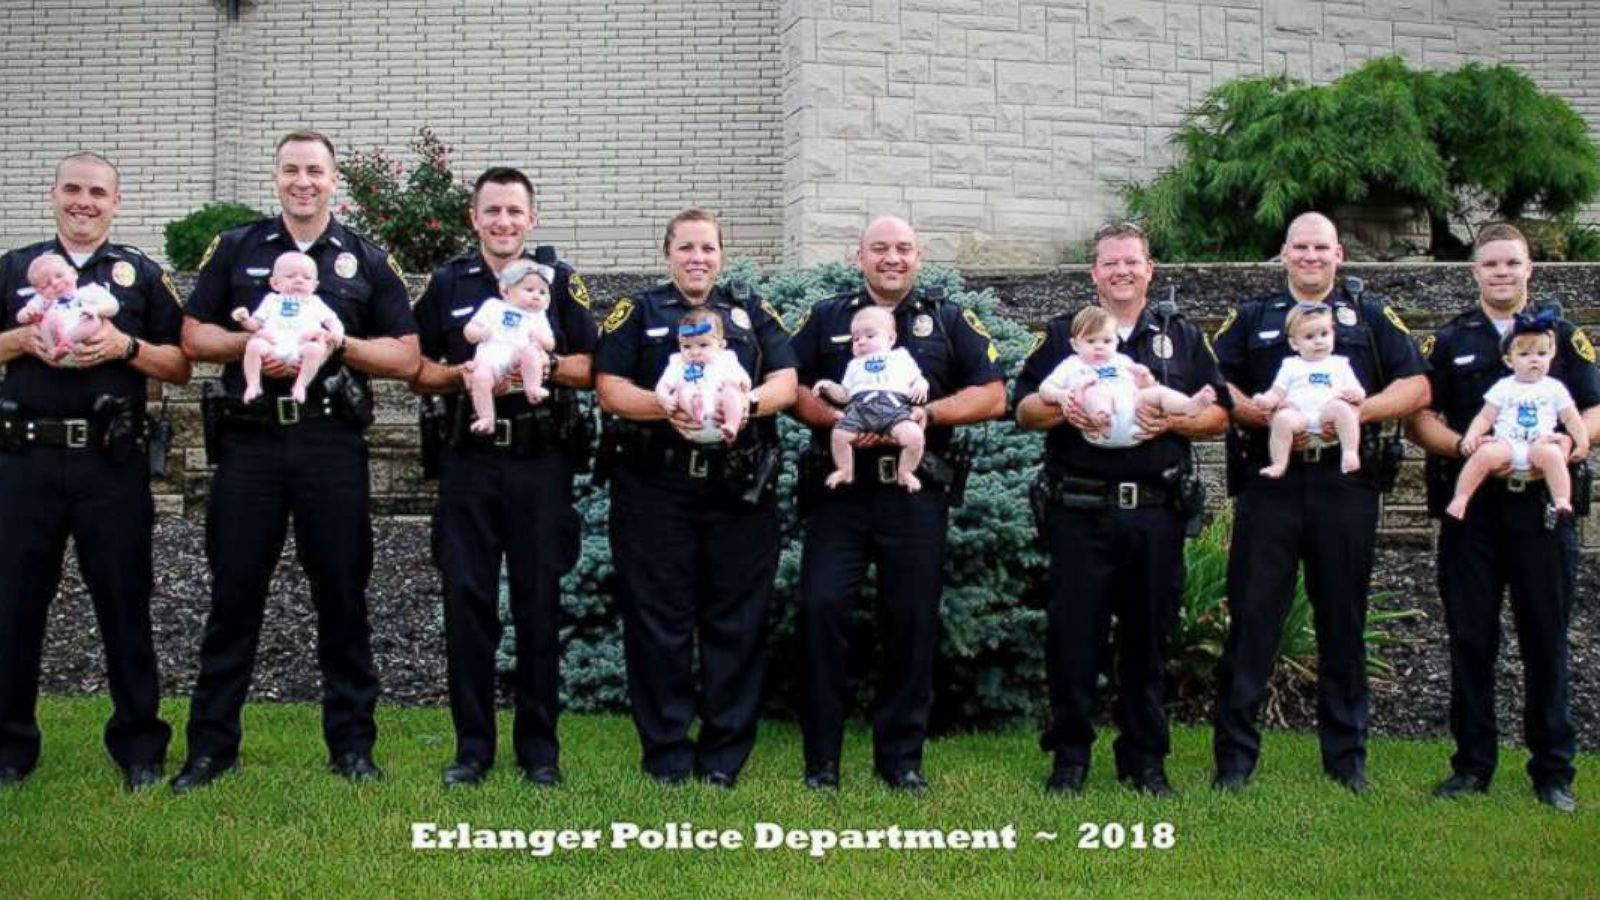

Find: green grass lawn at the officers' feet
<box><xmin>0</xmin><ymin>698</ymin><xmax>1600</xmax><ymax>898</ymax></box>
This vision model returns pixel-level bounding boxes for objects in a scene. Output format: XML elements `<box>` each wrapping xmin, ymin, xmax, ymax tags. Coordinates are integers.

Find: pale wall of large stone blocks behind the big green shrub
<box><xmin>782</xmin><ymin>0</ymin><xmax>1600</xmax><ymax>267</ymax></box>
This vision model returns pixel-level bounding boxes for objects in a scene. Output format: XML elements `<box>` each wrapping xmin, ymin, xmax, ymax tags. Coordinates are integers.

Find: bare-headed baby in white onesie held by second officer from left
<box><xmin>234</xmin><ymin>251</ymin><xmax>344</xmax><ymax>404</ymax></box>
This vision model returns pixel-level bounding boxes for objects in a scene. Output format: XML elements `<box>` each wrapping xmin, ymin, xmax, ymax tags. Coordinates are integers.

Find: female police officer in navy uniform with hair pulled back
<box><xmin>595</xmin><ymin>210</ymin><xmax>795</xmax><ymax>788</ymax></box>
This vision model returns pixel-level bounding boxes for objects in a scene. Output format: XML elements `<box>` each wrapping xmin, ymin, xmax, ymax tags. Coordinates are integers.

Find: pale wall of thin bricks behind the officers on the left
<box><xmin>0</xmin><ymin>0</ymin><xmax>781</xmax><ymax>271</ymax></box>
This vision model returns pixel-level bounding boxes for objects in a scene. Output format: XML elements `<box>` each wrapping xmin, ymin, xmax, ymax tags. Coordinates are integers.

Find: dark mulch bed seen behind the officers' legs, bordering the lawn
<box><xmin>28</xmin><ymin>516</ymin><xmax>1600</xmax><ymax>751</ymax></box>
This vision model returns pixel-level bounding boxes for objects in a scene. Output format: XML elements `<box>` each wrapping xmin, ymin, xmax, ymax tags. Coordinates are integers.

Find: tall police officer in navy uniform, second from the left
<box><xmin>173</xmin><ymin>131</ymin><xmax>421</xmax><ymax>791</ymax></box>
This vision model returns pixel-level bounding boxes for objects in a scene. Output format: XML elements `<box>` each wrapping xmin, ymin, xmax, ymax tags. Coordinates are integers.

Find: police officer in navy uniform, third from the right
<box><xmin>1013</xmin><ymin>224</ymin><xmax>1230</xmax><ymax>796</ymax></box>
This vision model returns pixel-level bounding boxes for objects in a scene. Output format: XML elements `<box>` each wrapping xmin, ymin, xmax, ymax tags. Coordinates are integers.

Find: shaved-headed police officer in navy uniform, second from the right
<box><xmin>1213</xmin><ymin>213</ymin><xmax>1427</xmax><ymax>793</ymax></box>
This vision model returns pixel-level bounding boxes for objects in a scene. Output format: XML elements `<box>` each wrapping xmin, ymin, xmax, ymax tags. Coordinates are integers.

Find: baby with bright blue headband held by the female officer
<box><xmin>656</xmin><ymin>307</ymin><xmax>750</xmax><ymax>444</ymax></box>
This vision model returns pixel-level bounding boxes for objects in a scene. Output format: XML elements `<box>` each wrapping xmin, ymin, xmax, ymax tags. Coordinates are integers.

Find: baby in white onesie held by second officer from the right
<box><xmin>1253</xmin><ymin>299</ymin><xmax>1366</xmax><ymax>479</ymax></box>
